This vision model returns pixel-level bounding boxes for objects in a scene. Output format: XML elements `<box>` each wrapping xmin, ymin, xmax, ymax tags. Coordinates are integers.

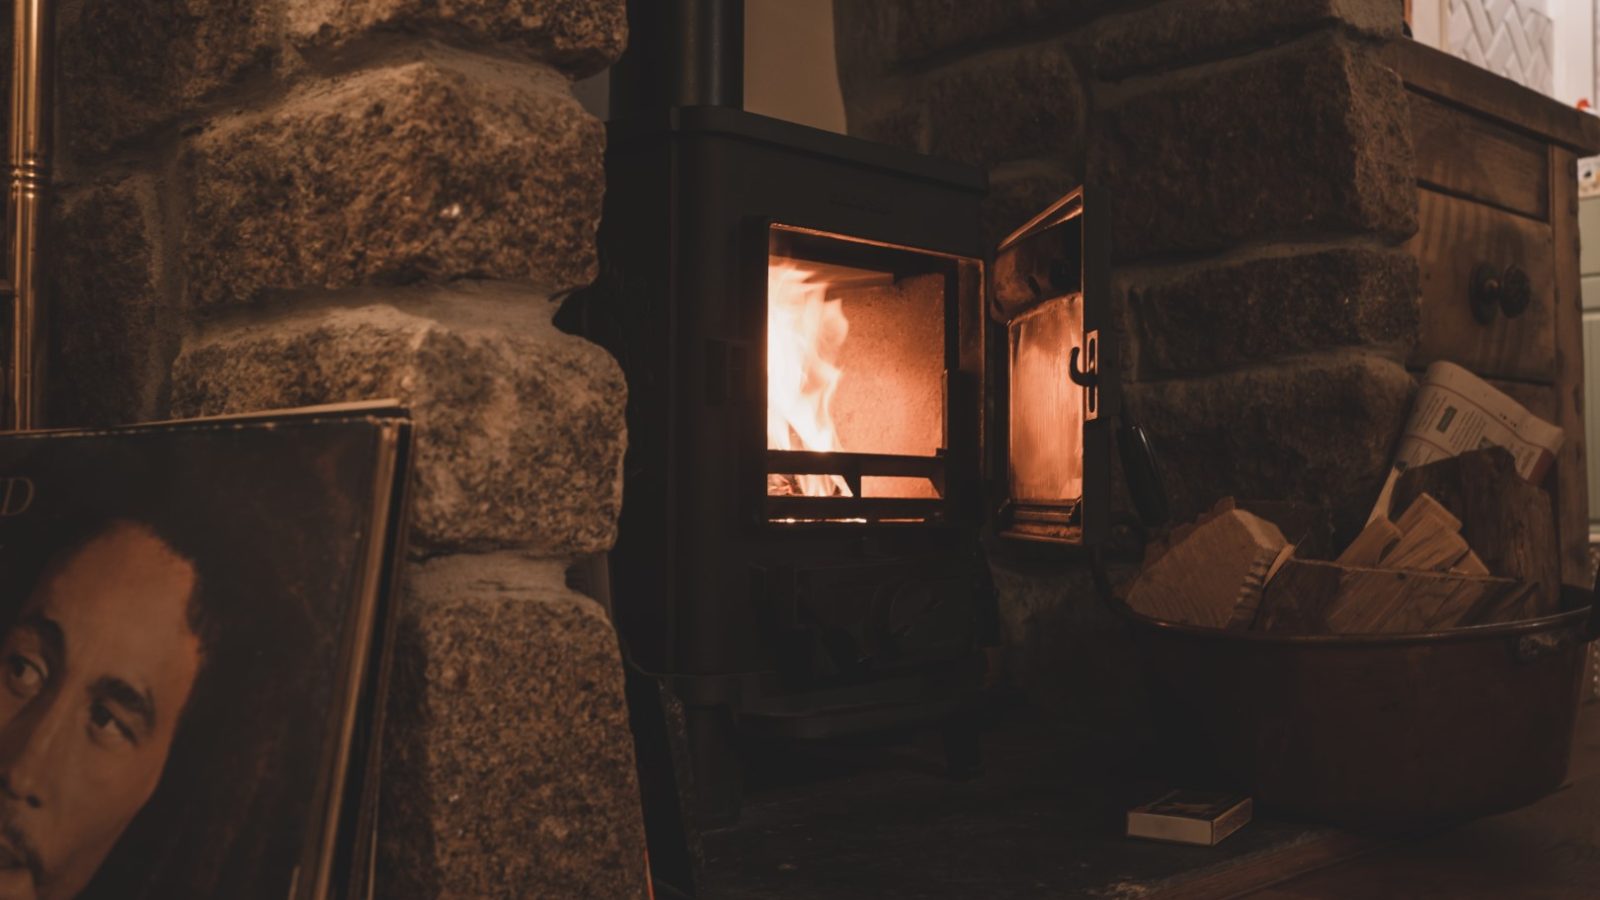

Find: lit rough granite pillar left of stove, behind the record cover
<box><xmin>46</xmin><ymin>0</ymin><xmax>645</xmax><ymax>900</ymax></box>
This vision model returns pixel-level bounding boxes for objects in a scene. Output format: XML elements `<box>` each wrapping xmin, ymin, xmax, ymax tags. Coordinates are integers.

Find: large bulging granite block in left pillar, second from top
<box><xmin>182</xmin><ymin>58</ymin><xmax>605</xmax><ymax>307</ymax></box>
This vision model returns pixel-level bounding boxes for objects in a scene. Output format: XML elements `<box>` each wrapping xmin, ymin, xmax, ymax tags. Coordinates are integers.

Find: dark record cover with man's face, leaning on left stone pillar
<box><xmin>0</xmin><ymin>410</ymin><xmax>408</xmax><ymax>900</ymax></box>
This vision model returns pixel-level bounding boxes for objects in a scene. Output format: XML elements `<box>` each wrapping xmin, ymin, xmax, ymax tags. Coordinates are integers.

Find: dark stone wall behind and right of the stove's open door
<box><xmin>834</xmin><ymin>0</ymin><xmax>1419</xmax><ymax>723</ymax></box>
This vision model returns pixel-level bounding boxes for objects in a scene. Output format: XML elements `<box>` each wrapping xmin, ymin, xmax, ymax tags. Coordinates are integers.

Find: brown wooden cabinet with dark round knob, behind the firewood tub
<box><xmin>1392</xmin><ymin>42</ymin><xmax>1600</xmax><ymax>585</ymax></box>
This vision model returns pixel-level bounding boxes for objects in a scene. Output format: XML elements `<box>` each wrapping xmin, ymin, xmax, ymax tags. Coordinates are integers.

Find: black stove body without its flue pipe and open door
<box><xmin>581</xmin><ymin>106</ymin><xmax>990</xmax><ymax>817</ymax></box>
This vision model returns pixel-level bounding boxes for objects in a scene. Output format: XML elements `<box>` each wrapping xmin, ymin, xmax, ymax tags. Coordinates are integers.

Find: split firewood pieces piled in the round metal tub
<box><xmin>1126</xmin><ymin>448</ymin><xmax>1560</xmax><ymax>634</ymax></box>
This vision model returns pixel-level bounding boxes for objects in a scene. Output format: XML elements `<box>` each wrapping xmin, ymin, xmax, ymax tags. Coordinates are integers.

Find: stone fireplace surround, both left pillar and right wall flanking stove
<box><xmin>46</xmin><ymin>0</ymin><xmax>1418</xmax><ymax>900</ymax></box>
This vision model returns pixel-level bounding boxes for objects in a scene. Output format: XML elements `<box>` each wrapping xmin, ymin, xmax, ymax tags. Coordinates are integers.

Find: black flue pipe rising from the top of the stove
<box><xmin>611</xmin><ymin>0</ymin><xmax>744</xmax><ymax>119</ymax></box>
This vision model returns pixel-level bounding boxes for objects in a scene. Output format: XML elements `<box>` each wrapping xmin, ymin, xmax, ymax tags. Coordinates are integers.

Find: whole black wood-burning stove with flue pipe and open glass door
<box><xmin>562</xmin><ymin>0</ymin><xmax>1115</xmax><ymax>822</ymax></box>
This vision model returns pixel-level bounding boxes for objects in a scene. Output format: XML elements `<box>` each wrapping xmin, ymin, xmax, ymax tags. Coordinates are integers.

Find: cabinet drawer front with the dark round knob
<box><xmin>1406</xmin><ymin>187</ymin><xmax>1558</xmax><ymax>381</ymax></box>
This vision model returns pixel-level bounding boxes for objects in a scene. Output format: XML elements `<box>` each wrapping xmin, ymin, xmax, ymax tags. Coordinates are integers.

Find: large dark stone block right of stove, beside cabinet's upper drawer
<box><xmin>1090</xmin><ymin>35</ymin><xmax>1416</xmax><ymax>259</ymax></box>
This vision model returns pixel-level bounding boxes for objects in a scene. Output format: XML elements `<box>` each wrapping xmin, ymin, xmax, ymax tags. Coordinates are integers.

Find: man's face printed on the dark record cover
<box><xmin>0</xmin><ymin>522</ymin><xmax>202</xmax><ymax>900</ymax></box>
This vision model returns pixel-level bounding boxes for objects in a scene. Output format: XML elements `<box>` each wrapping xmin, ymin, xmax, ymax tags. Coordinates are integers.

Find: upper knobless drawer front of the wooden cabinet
<box><xmin>1406</xmin><ymin>93</ymin><xmax>1550</xmax><ymax>221</ymax></box>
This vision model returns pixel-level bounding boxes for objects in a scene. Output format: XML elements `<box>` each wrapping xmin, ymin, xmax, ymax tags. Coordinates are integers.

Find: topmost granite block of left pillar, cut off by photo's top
<box><xmin>288</xmin><ymin>0</ymin><xmax>627</xmax><ymax>78</ymax></box>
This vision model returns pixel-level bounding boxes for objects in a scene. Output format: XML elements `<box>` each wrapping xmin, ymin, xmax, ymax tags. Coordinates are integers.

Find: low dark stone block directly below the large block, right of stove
<box><xmin>1118</xmin><ymin>247</ymin><xmax>1421</xmax><ymax>376</ymax></box>
